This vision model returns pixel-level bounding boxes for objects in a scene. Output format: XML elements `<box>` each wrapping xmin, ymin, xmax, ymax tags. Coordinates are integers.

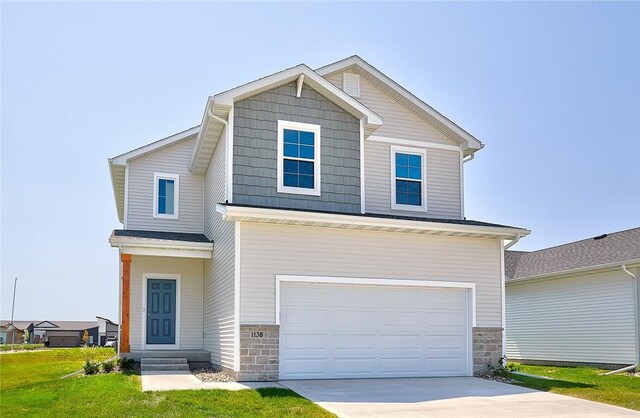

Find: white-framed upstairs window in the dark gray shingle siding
<box><xmin>278</xmin><ymin>120</ymin><xmax>320</xmax><ymax>196</ymax></box>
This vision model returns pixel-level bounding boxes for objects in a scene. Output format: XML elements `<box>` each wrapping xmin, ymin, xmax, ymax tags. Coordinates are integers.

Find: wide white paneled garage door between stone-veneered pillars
<box><xmin>280</xmin><ymin>282</ymin><xmax>471</xmax><ymax>379</ymax></box>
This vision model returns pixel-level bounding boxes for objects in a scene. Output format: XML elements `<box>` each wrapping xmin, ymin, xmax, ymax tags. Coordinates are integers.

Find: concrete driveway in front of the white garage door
<box><xmin>280</xmin><ymin>377</ymin><xmax>640</xmax><ymax>418</ymax></box>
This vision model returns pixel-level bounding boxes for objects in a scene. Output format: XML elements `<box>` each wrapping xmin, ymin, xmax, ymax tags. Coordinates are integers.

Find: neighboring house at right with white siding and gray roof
<box><xmin>505</xmin><ymin>228</ymin><xmax>640</xmax><ymax>368</ymax></box>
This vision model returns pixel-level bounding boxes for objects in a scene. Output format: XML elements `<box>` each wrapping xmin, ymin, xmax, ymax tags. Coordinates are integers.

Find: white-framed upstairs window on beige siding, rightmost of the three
<box><xmin>391</xmin><ymin>146</ymin><xmax>427</xmax><ymax>211</ymax></box>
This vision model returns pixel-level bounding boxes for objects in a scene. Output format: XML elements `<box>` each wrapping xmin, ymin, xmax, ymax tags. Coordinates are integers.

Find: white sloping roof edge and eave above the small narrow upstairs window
<box><xmin>109</xmin><ymin>125</ymin><xmax>200</xmax><ymax>222</ymax></box>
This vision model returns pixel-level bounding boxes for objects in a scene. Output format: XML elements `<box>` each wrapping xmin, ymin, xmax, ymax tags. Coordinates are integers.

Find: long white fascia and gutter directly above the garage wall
<box><xmin>216</xmin><ymin>203</ymin><xmax>531</xmax><ymax>239</ymax></box>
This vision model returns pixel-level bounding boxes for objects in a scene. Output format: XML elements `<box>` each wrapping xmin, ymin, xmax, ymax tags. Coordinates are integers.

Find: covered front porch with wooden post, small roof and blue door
<box><xmin>109</xmin><ymin>230</ymin><xmax>213</xmax><ymax>367</ymax></box>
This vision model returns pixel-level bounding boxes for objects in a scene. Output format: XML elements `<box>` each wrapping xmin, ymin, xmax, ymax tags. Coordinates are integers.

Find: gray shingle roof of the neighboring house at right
<box><xmin>504</xmin><ymin>227</ymin><xmax>640</xmax><ymax>282</ymax></box>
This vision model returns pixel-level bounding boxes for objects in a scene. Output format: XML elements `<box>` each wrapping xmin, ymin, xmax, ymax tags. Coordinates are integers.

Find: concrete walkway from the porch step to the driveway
<box><xmin>141</xmin><ymin>371</ymin><xmax>282</xmax><ymax>392</ymax></box>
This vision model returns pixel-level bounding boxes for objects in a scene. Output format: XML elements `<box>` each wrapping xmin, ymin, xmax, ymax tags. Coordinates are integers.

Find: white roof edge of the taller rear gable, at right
<box><xmin>316</xmin><ymin>55</ymin><xmax>484</xmax><ymax>155</ymax></box>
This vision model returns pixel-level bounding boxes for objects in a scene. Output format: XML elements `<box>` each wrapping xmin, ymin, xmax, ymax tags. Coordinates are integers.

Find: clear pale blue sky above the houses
<box><xmin>0</xmin><ymin>2</ymin><xmax>640</xmax><ymax>320</ymax></box>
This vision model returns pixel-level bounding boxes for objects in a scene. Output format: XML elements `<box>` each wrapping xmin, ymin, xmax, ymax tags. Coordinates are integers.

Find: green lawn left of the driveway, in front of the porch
<box><xmin>0</xmin><ymin>350</ymin><xmax>333</xmax><ymax>418</ymax></box>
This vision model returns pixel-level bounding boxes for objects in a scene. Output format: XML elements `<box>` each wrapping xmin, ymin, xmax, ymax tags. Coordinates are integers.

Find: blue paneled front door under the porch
<box><xmin>147</xmin><ymin>279</ymin><xmax>176</xmax><ymax>344</ymax></box>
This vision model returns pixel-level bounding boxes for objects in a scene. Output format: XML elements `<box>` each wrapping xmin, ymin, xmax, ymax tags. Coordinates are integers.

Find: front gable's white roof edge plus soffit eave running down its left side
<box><xmin>189</xmin><ymin>64</ymin><xmax>382</xmax><ymax>174</ymax></box>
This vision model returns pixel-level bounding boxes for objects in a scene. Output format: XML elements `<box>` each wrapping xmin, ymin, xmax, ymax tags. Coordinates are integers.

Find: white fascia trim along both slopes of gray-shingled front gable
<box><xmin>214</xmin><ymin>64</ymin><xmax>382</xmax><ymax>125</ymax></box>
